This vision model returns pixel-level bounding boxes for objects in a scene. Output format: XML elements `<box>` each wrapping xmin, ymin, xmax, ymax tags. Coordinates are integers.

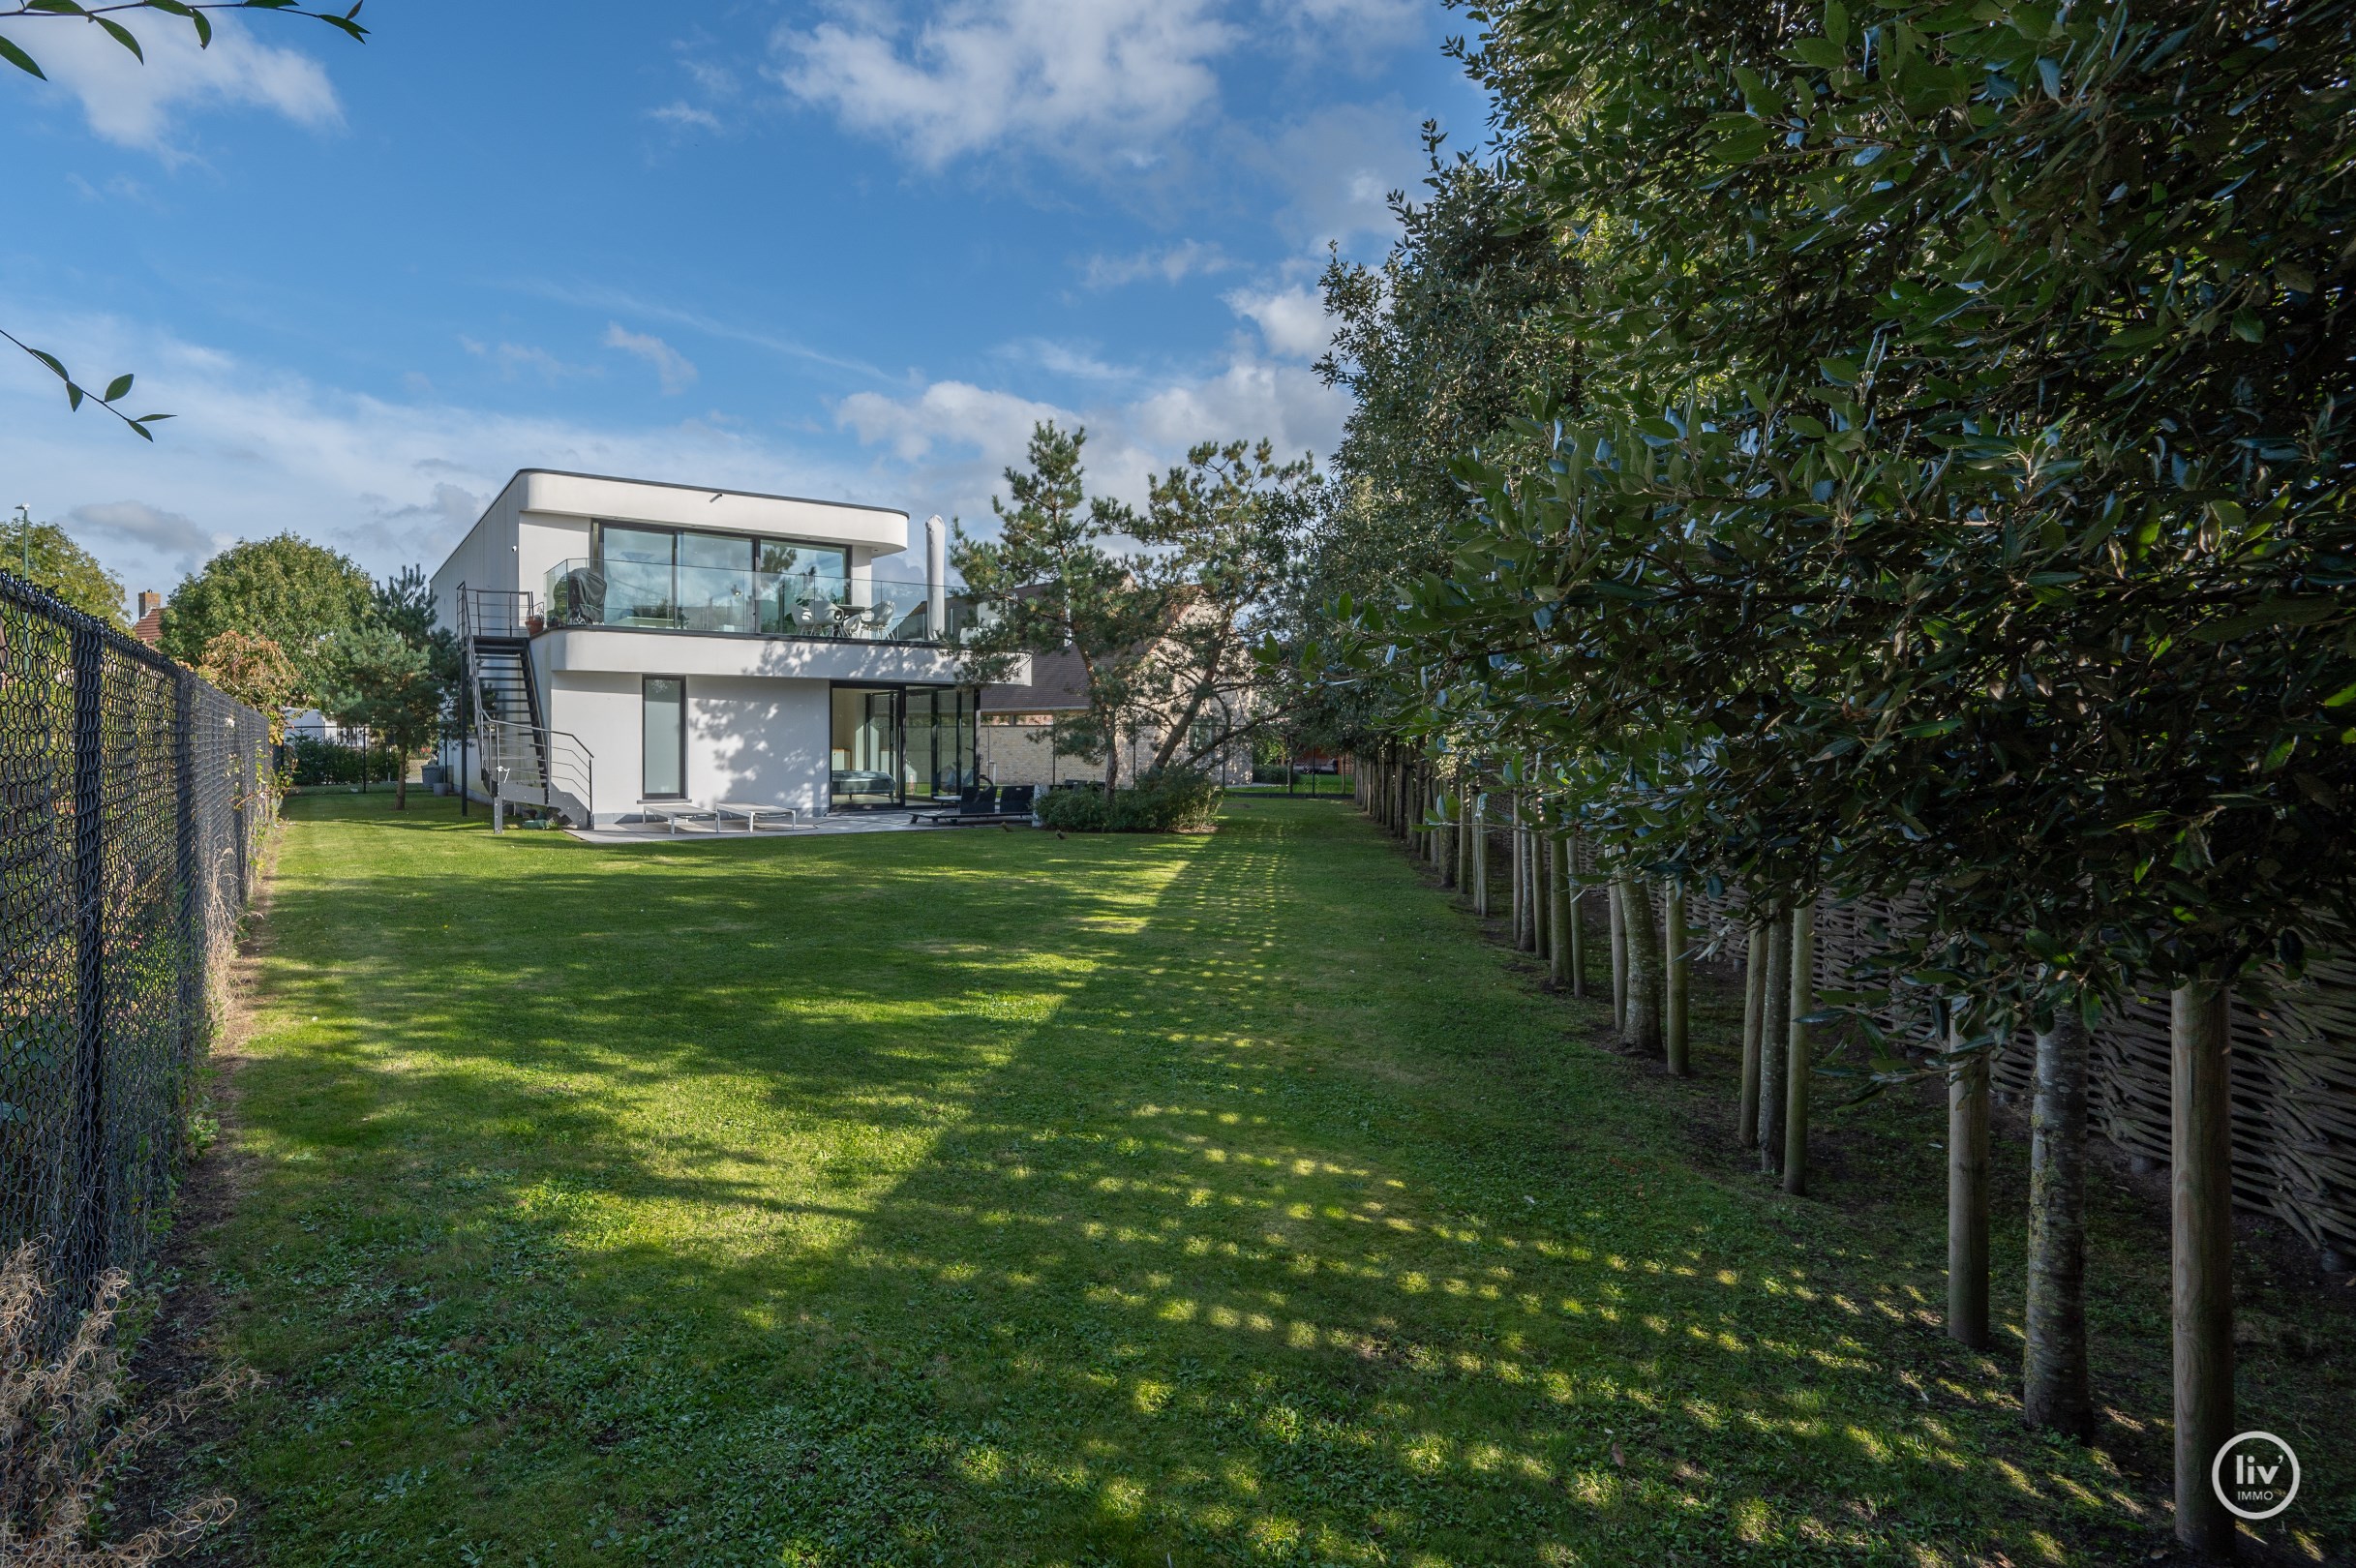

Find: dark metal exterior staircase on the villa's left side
<box><xmin>457</xmin><ymin>584</ymin><xmax>596</xmax><ymax>829</ymax></box>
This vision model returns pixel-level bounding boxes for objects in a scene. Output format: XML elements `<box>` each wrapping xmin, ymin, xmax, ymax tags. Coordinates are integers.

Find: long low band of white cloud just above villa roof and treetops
<box><xmin>0</xmin><ymin>309</ymin><xmax>1347</xmax><ymax>600</ymax></box>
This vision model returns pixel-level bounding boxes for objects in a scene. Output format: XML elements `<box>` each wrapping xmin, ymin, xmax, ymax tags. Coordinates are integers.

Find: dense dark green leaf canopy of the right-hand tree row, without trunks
<box><xmin>1364</xmin><ymin>0</ymin><xmax>2356</xmax><ymax>1026</ymax></box>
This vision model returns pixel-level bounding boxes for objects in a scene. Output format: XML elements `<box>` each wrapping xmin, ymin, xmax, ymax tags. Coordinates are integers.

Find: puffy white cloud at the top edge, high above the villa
<box><xmin>775</xmin><ymin>0</ymin><xmax>1244</xmax><ymax>167</ymax></box>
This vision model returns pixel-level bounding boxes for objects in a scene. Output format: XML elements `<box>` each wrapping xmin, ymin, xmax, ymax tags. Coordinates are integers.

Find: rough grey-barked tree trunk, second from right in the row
<box><xmin>2021</xmin><ymin>1001</ymin><xmax>2095</xmax><ymax>1441</ymax></box>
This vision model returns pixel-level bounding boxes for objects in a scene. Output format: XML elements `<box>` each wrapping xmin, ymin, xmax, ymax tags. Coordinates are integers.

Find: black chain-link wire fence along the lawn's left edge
<box><xmin>0</xmin><ymin>572</ymin><xmax>276</xmax><ymax>1335</ymax></box>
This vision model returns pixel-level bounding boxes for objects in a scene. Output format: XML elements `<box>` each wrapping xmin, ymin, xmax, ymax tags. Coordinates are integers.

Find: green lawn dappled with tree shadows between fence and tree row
<box><xmin>156</xmin><ymin>796</ymin><xmax>2356</xmax><ymax>1568</ymax></box>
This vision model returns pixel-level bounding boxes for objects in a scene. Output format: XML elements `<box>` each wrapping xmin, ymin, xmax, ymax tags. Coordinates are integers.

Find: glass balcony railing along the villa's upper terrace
<box><xmin>547</xmin><ymin>560</ymin><xmax>971</xmax><ymax>643</ymax></box>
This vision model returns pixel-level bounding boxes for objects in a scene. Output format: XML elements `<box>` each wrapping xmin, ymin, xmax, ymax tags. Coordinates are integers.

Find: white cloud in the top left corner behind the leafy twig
<box><xmin>12</xmin><ymin>12</ymin><xmax>344</xmax><ymax>163</ymax></box>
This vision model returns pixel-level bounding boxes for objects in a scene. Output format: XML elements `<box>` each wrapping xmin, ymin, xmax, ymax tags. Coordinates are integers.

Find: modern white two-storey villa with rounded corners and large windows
<box><xmin>434</xmin><ymin>468</ymin><xmax>1030</xmax><ymax>827</ymax></box>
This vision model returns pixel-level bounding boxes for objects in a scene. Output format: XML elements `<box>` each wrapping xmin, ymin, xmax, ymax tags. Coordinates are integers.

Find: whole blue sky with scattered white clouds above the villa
<box><xmin>0</xmin><ymin>0</ymin><xmax>1484</xmax><ymax>591</ymax></box>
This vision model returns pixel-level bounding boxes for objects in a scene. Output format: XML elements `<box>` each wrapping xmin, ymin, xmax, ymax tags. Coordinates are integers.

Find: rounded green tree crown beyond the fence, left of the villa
<box><xmin>163</xmin><ymin>534</ymin><xmax>377</xmax><ymax>704</ymax></box>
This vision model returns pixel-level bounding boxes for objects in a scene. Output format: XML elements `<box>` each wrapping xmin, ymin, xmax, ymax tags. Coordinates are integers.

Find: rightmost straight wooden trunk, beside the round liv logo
<box><xmin>2167</xmin><ymin>984</ymin><xmax>2233</xmax><ymax>1556</ymax></box>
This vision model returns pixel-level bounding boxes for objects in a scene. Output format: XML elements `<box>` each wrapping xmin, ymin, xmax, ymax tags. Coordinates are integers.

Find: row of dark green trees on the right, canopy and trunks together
<box><xmin>1303</xmin><ymin>0</ymin><xmax>2356</xmax><ymax>1553</ymax></box>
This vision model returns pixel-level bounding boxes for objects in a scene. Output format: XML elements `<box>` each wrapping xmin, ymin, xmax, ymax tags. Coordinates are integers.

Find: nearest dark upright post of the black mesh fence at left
<box><xmin>71</xmin><ymin>619</ymin><xmax>113</xmax><ymax>1288</ymax></box>
